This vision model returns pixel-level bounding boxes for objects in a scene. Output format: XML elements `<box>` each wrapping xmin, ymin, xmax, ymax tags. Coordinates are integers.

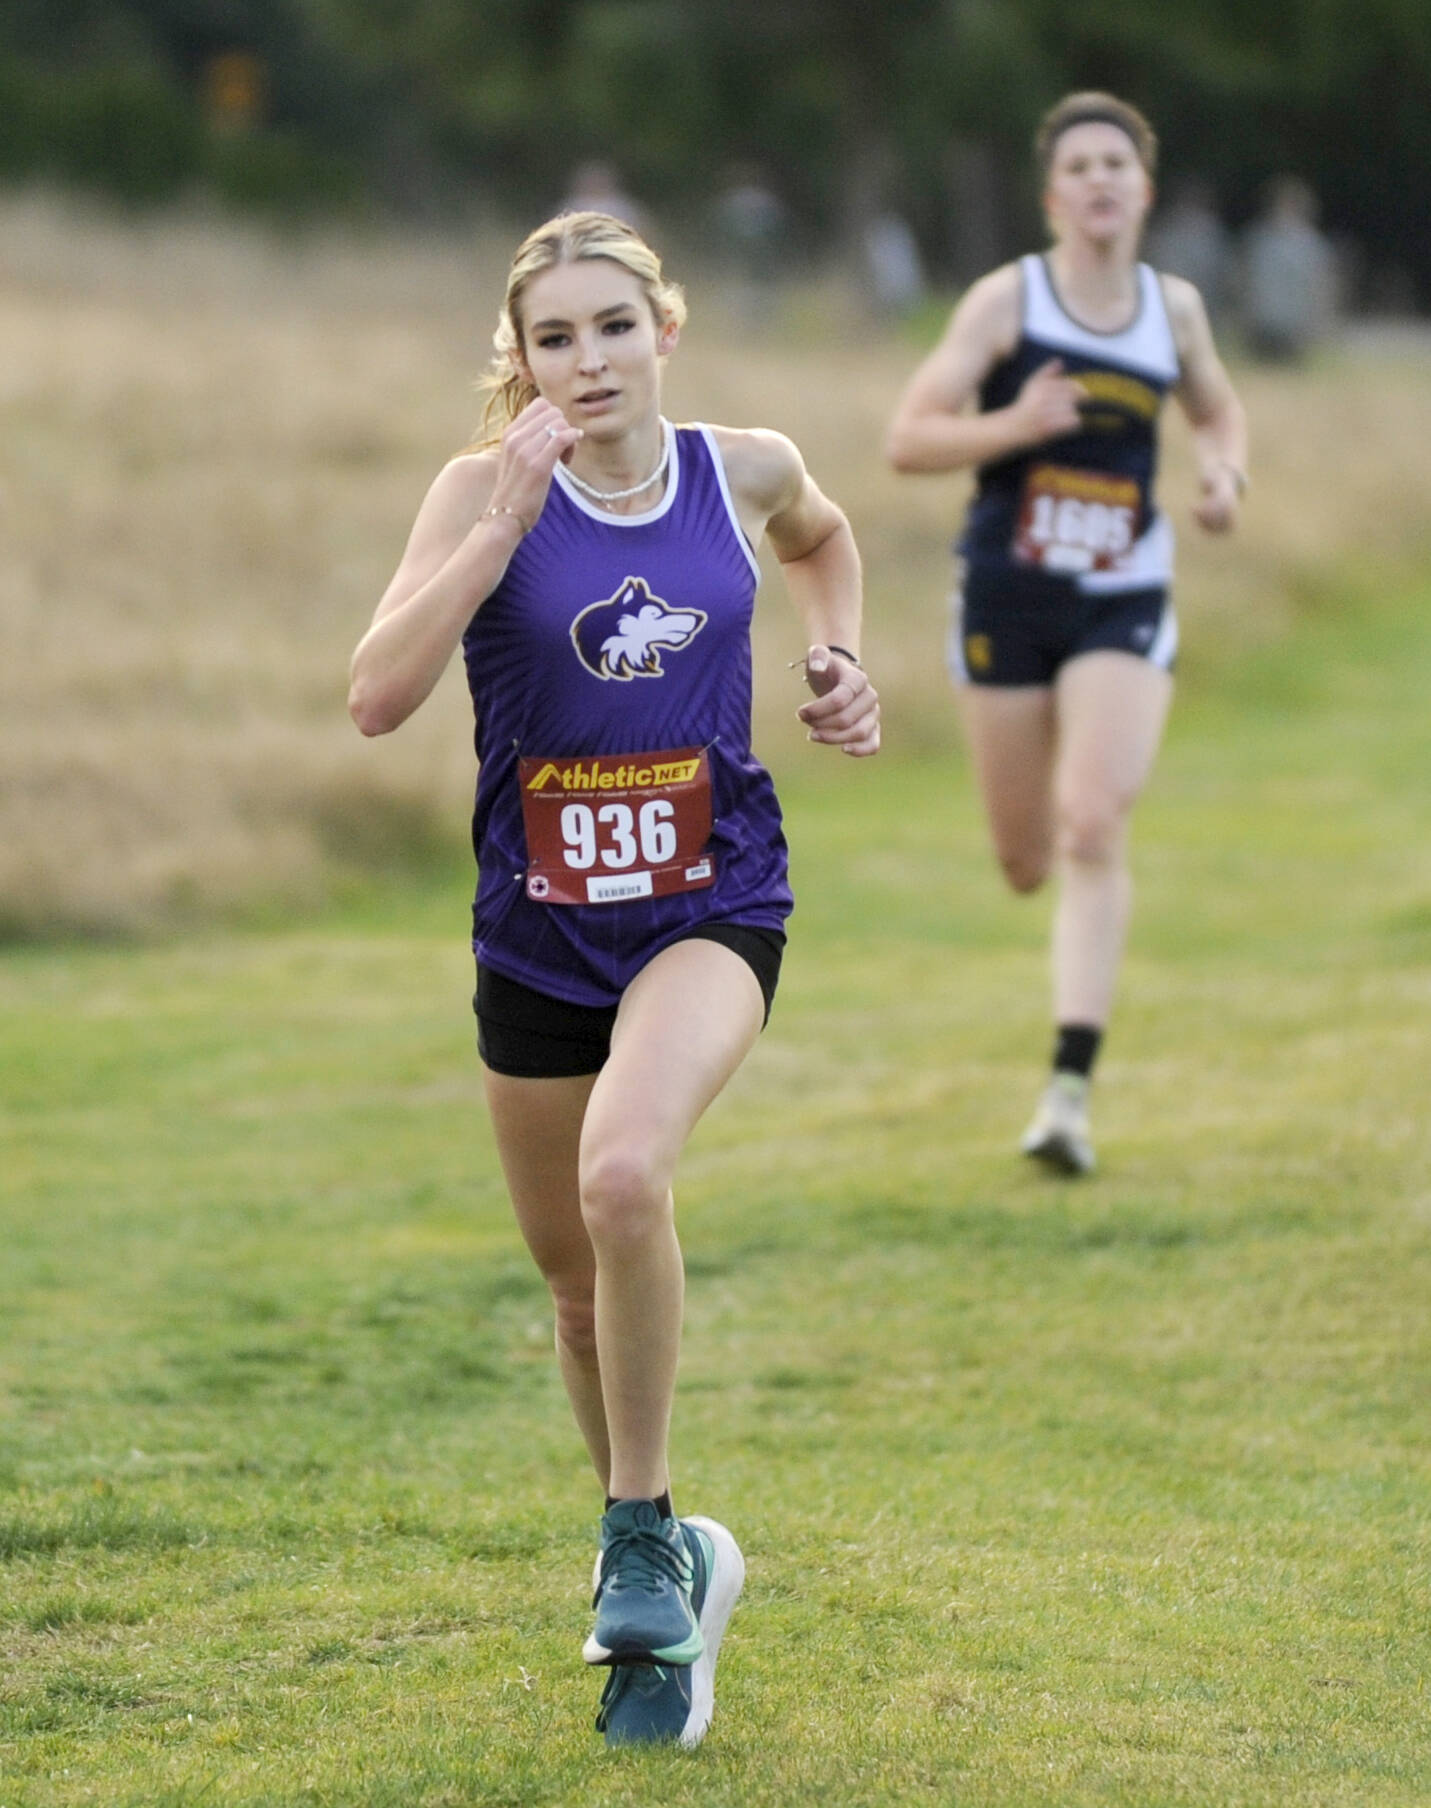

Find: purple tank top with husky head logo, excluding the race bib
<box><xmin>463</xmin><ymin>423</ymin><xmax>792</xmax><ymax>1005</ymax></box>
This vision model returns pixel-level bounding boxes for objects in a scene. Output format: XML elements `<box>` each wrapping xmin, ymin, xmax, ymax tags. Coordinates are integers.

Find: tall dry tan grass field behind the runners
<box><xmin>0</xmin><ymin>199</ymin><xmax>1431</xmax><ymax>933</ymax></box>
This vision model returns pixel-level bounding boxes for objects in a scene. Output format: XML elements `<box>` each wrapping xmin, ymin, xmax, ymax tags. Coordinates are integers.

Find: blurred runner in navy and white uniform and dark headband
<box><xmin>890</xmin><ymin>92</ymin><xmax>1246</xmax><ymax>1175</ymax></box>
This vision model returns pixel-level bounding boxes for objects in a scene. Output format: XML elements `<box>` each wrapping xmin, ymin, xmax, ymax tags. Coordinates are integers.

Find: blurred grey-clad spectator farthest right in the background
<box><xmin>1243</xmin><ymin>175</ymin><xmax>1337</xmax><ymax>363</ymax></box>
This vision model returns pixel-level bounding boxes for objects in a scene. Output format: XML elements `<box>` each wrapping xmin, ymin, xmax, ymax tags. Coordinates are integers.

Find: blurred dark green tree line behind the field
<box><xmin>0</xmin><ymin>0</ymin><xmax>1431</xmax><ymax>307</ymax></box>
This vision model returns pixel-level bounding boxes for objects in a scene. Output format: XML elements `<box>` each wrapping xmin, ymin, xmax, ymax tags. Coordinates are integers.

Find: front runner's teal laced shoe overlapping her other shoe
<box><xmin>581</xmin><ymin>1501</ymin><xmax>704</xmax><ymax>1663</ymax></box>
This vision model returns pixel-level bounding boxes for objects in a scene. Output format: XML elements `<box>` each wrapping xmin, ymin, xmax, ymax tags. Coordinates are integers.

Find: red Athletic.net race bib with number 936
<box><xmin>517</xmin><ymin>747</ymin><xmax>715</xmax><ymax>904</ymax></box>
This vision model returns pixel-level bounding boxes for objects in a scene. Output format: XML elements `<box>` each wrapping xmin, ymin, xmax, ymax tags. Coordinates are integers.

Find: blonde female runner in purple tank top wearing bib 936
<box><xmin>349</xmin><ymin>213</ymin><xmax>879</xmax><ymax>1745</ymax></box>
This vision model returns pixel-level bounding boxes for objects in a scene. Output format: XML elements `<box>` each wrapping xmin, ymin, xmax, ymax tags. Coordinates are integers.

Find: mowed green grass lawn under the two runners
<box><xmin>0</xmin><ymin>593</ymin><xmax>1431</xmax><ymax>1808</ymax></box>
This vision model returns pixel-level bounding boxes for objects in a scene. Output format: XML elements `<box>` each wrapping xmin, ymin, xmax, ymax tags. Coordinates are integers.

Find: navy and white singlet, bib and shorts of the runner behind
<box><xmin>950</xmin><ymin>255</ymin><xmax>1181</xmax><ymax>683</ymax></box>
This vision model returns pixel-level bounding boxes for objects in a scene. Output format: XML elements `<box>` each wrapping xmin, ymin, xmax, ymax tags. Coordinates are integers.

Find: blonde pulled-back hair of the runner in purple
<box><xmin>472</xmin><ymin>213</ymin><xmax>686</xmax><ymax>450</ymax></box>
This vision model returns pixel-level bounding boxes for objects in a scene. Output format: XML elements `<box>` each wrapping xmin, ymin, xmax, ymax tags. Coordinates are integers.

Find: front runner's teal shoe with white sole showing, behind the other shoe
<box><xmin>597</xmin><ymin>1517</ymin><xmax>745</xmax><ymax>1750</ymax></box>
